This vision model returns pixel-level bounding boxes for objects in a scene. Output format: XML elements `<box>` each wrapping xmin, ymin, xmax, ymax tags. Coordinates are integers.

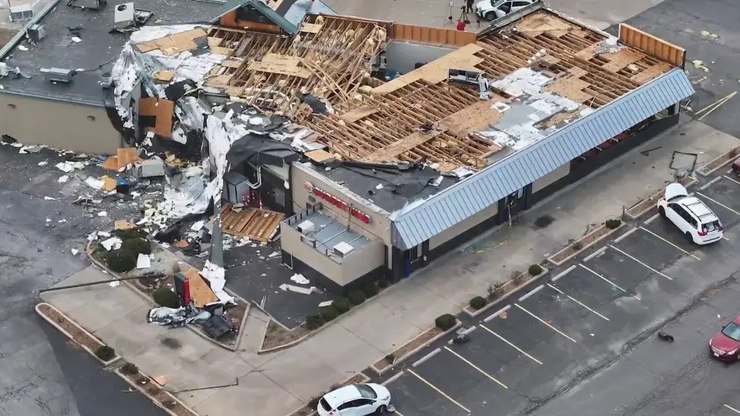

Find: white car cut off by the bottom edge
<box><xmin>316</xmin><ymin>383</ymin><xmax>391</xmax><ymax>416</ymax></box>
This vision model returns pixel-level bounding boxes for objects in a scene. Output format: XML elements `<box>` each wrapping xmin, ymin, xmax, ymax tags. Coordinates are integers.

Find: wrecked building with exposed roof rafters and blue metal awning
<box><xmin>0</xmin><ymin>0</ymin><xmax>694</xmax><ymax>293</ymax></box>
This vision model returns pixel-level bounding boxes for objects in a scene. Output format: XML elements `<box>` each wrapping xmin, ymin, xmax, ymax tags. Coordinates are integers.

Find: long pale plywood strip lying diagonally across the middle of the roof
<box><xmin>373</xmin><ymin>43</ymin><xmax>483</xmax><ymax>94</ymax></box>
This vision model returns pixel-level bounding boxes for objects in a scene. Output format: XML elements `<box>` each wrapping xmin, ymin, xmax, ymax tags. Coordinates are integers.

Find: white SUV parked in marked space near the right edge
<box><xmin>658</xmin><ymin>183</ymin><xmax>724</xmax><ymax>245</ymax></box>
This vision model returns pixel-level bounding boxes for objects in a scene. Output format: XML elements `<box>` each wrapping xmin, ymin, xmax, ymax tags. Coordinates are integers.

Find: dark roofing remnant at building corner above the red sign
<box><xmin>315</xmin><ymin>162</ymin><xmax>458</xmax><ymax>212</ymax></box>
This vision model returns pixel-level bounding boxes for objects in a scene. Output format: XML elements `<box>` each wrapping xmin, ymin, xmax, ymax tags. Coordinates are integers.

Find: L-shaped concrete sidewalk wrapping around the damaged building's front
<box><xmin>43</xmin><ymin>121</ymin><xmax>740</xmax><ymax>416</ymax></box>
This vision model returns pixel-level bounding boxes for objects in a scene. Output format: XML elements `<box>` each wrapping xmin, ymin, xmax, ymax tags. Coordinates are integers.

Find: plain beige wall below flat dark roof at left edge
<box><xmin>0</xmin><ymin>94</ymin><xmax>122</xmax><ymax>154</ymax></box>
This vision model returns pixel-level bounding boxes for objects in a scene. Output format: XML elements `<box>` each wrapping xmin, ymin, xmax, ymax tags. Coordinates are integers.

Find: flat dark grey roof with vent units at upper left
<box><xmin>0</xmin><ymin>0</ymin><xmax>228</xmax><ymax>106</ymax></box>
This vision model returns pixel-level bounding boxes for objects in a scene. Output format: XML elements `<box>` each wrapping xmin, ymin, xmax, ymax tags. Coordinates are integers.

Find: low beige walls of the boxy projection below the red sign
<box><xmin>280</xmin><ymin>221</ymin><xmax>385</xmax><ymax>286</ymax></box>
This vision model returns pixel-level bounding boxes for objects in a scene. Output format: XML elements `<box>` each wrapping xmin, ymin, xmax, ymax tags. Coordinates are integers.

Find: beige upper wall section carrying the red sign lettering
<box><xmin>290</xmin><ymin>163</ymin><xmax>391</xmax><ymax>246</ymax></box>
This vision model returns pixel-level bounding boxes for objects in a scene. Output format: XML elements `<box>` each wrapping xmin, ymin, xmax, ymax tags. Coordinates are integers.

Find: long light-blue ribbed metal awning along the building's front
<box><xmin>391</xmin><ymin>68</ymin><xmax>694</xmax><ymax>250</ymax></box>
